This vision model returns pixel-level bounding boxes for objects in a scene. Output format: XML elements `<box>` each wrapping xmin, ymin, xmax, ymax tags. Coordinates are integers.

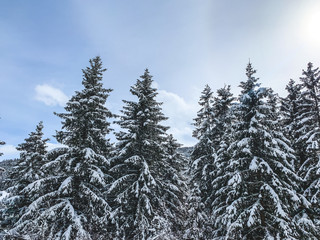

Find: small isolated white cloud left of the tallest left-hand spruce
<box><xmin>35</xmin><ymin>84</ymin><xmax>69</xmax><ymax>106</ymax></box>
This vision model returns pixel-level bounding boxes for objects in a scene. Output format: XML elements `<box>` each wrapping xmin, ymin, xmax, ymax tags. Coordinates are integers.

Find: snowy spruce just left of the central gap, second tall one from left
<box><xmin>109</xmin><ymin>69</ymin><xmax>182</xmax><ymax>240</ymax></box>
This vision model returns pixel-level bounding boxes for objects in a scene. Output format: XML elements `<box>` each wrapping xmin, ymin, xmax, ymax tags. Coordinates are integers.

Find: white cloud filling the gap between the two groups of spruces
<box><xmin>158</xmin><ymin>90</ymin><xmax>198</xmax><ymax>146</ymax></box>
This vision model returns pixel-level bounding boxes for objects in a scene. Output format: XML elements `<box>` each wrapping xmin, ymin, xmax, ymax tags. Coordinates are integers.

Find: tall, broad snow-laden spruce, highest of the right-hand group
<box><xmin>216</xmin><ymin>63</ymin><xmax>305</xmax><ymax>239</ymax></box>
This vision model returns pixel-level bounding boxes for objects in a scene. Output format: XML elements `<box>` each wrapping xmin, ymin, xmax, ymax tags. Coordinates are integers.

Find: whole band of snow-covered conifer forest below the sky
<box><xmin>0</xmin><ymin>57</ymin><xmax>320</xmax><ymax>240</ymax></box>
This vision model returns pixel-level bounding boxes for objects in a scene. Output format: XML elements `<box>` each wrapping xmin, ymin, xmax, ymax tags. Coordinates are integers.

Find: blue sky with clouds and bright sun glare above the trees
<box><xmin>0</xmin><ymin>0</ymin><xmax>320</xmax><ymax>160</ymax></box>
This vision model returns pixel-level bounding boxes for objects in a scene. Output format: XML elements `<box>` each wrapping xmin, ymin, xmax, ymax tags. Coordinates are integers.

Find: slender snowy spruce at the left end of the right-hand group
<box><xmin>185</xmin><ymin>85</ymin><xmax>214</xmax><ymax>239</ymax></box>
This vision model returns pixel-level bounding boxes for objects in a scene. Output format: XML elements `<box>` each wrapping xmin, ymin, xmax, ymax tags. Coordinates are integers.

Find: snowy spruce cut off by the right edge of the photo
<box><xmin>297</xmin><ymin>63</ymin><xmax>320</xmax><ymax>232</ymax></box>
